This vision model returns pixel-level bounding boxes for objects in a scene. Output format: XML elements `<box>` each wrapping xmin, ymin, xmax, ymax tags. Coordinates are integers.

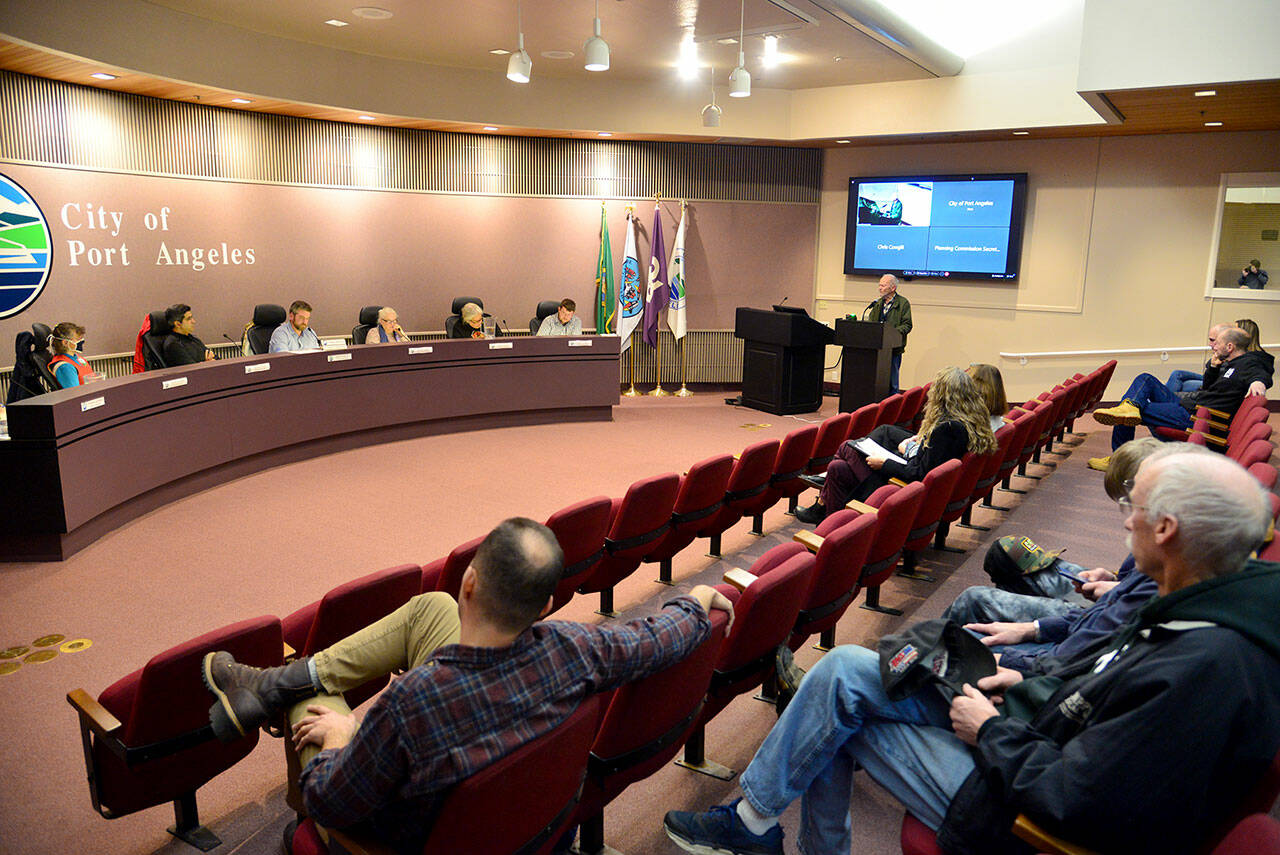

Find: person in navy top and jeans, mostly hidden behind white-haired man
<box><xmin>942</xmin><ymin>436</ymin><xmax>1172</xmax><ymax>675</ymax></box>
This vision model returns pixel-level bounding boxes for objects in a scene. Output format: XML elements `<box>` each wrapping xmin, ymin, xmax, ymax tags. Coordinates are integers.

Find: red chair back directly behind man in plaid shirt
<box><xmin>422</xmin><ymin>695</ymin><xmax>602</xmax><ymax>855</ymax></box>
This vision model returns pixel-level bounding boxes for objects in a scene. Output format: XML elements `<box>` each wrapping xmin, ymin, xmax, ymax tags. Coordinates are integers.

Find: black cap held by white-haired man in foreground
<box><xmin>877</xmin><ymin>618</ymin><xmax>996</xmax><ymax>700</ymax></box>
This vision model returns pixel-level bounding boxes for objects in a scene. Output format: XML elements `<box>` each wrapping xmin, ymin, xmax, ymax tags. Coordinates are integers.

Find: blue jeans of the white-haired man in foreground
<box><xmin>740</xmin><ymin>645</ymin><xmax>974</xmax><ymax>855</ymax></box>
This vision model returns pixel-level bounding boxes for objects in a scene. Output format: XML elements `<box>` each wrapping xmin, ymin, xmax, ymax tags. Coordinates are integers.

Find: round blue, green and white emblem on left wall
<box><xmin>0</xmin><ymin>175</ymin><xmax>54</xmax><ymax>319</ymax></box>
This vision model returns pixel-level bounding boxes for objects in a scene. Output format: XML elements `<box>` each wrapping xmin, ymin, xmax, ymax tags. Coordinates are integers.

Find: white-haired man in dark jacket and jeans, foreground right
<box><xmin>666</xmin><ymin>447</ymin><xmax>1280</xmax><ymax>855</ymax></box>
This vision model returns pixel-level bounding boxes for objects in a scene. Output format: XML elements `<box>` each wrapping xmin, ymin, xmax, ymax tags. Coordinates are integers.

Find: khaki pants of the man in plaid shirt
<box><xmin>285</xmin><ymin>591</ymin><xmax>458</xmax><ymax>767</ymax></box>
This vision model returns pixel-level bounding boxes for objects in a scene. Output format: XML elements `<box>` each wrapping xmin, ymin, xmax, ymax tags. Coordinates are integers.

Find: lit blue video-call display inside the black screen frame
<box><xmin>854</xmin><ymin>179</ymin><xmax>1014</xmax><ymax>274</ymax></box>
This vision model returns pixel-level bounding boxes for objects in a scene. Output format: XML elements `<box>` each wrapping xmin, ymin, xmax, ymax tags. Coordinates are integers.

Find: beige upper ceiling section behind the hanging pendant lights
<box><xmin>151</xmin><ymin>0</ymin><xmax>931</xmax><ymax>90</ymax></box>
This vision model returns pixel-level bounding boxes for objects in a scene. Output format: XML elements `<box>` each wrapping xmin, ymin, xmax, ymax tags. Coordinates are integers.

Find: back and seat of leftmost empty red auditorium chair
<box><xmin>78</xmin><ymin>616</ymin><xmax>283</xmax><ymax>819</ymax></box>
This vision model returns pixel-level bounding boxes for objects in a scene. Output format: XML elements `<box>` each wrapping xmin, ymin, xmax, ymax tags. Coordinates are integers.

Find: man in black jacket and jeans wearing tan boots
<box><xmin>1089</xmin><ymin>326</ymin><xmax>1271</xmax><ymax>471</ymax></box>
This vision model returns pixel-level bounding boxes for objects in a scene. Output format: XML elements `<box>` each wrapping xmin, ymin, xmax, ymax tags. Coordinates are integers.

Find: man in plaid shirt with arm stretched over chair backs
<box><xmin>204</xmin><ymin>517</ymin><xmax>731</xmax><ymax>851</ymax></box>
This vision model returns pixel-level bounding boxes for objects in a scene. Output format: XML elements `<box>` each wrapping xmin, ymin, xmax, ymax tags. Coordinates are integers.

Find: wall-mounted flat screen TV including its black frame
<box><xmin>845</xmin><ymin>173</ymin><xmax>1027</xmax><ymax>282</ymax></box>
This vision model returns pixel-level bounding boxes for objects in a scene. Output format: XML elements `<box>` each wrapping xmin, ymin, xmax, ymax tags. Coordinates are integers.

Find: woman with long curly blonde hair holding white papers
<box><xmin>796</xmin><ymin>367</ymin><xmax>996</xmax><ymax>525</ymax></box>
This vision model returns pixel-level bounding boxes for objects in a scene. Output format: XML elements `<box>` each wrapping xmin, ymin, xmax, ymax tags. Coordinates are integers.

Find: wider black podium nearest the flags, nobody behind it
<box><xmin>733</xmin><ymin>308</ymin><xmax>833</xmax><ymax>416</ymax></box>
